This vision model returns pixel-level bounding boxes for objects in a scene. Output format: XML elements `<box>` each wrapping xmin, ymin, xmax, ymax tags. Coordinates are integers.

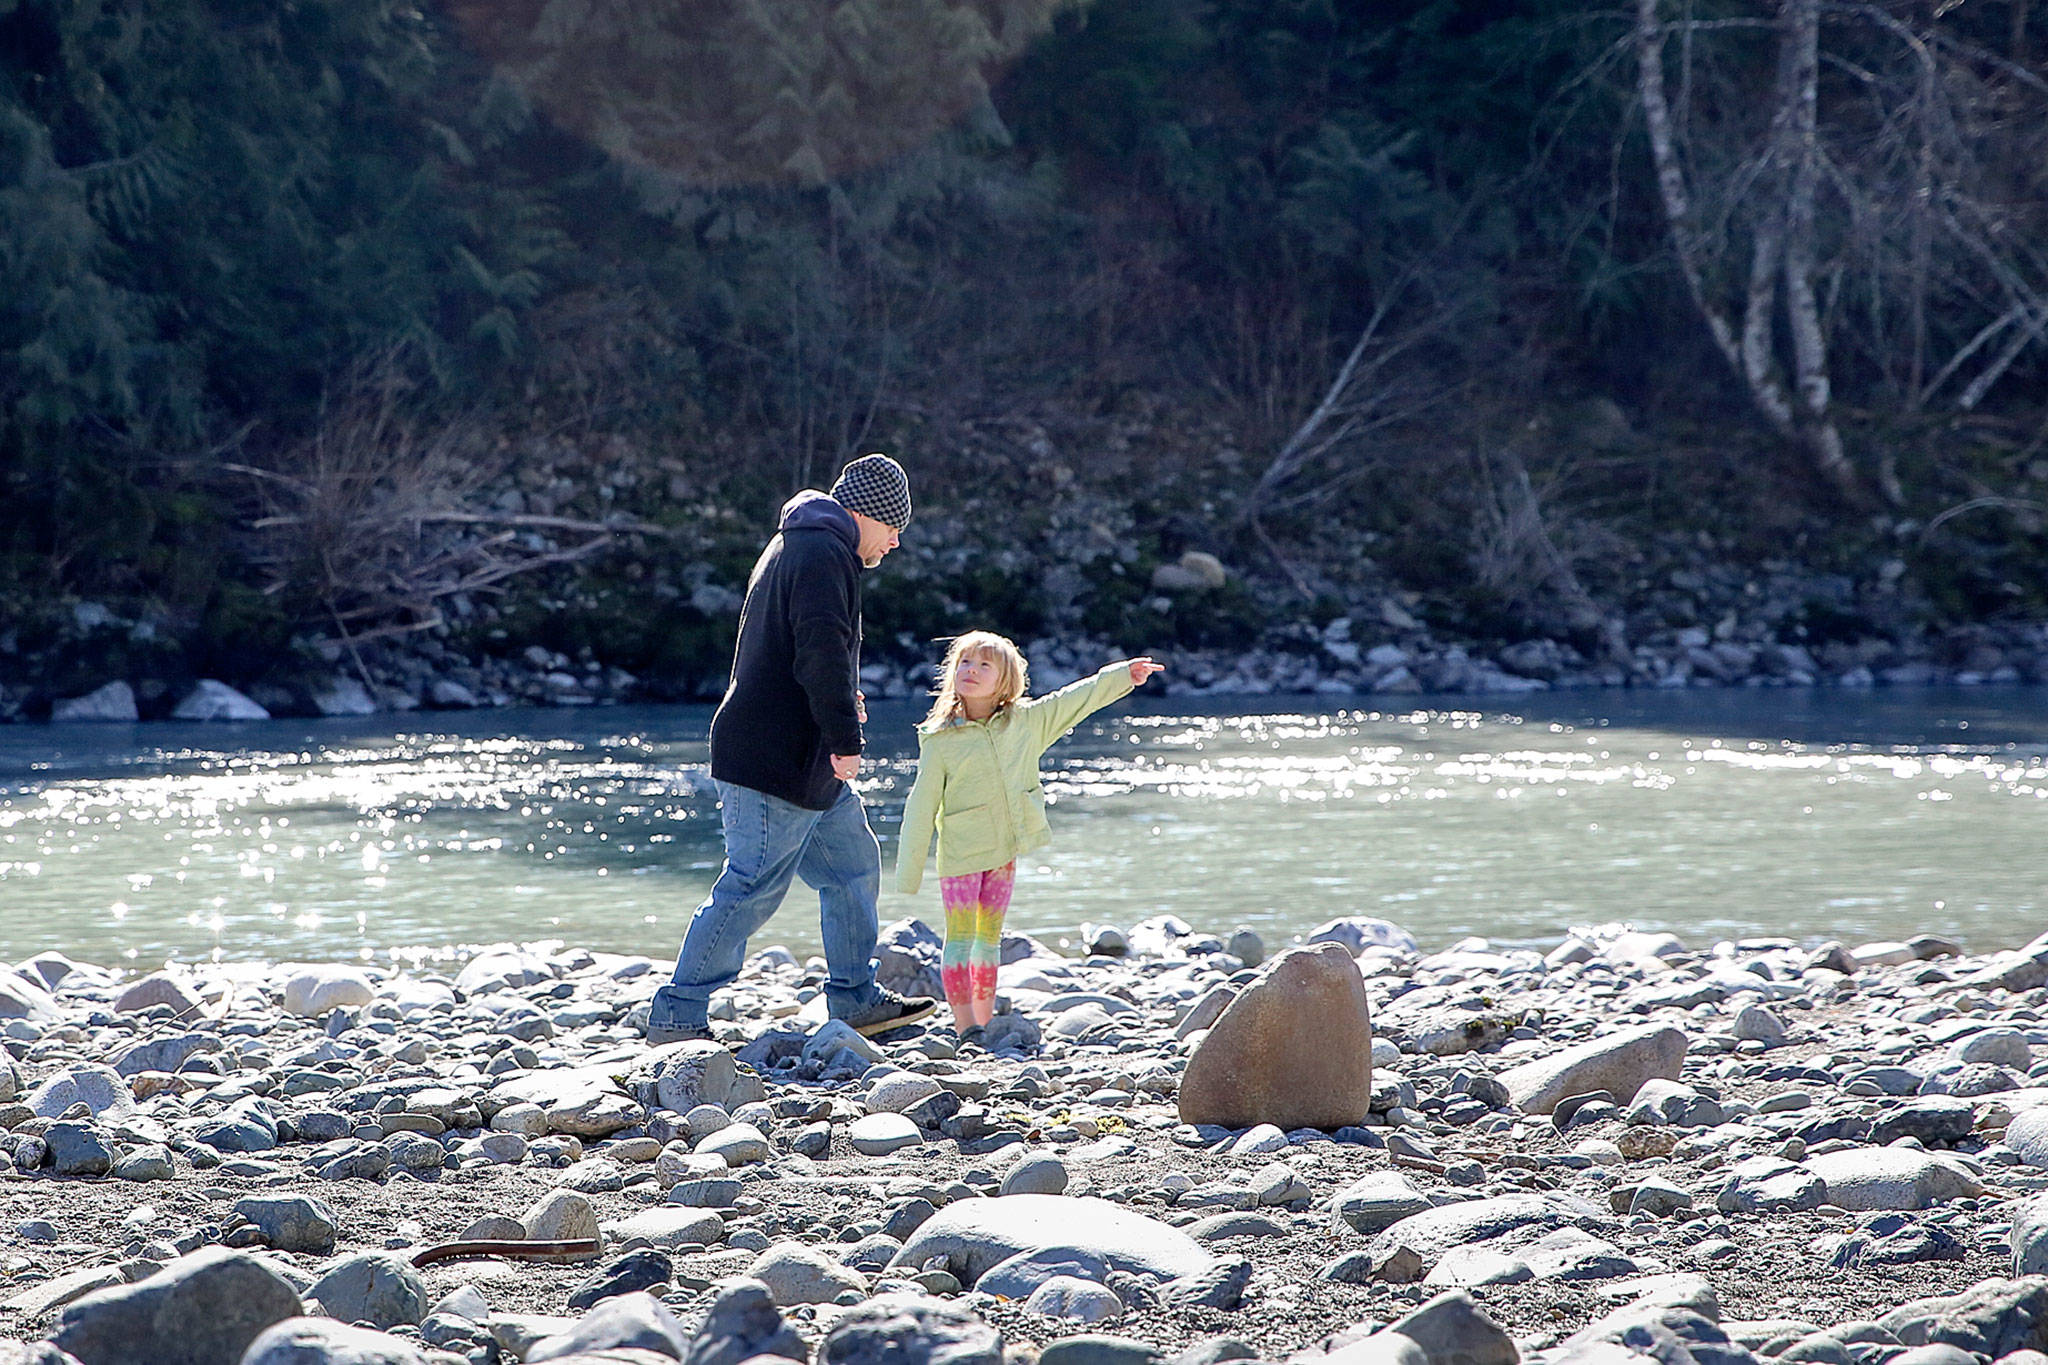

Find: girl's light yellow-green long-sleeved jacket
<box><xmin>897</xmin><ymin>663</ymin><xmax>1130</xmax><ymax>894</ymax></box>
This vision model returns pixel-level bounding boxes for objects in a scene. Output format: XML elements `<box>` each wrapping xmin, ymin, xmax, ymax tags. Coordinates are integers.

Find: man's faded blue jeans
<box><xmin>647</xmin><ymin>782</ymin><xmax>883</xmax><ymax>1027</ymax></box>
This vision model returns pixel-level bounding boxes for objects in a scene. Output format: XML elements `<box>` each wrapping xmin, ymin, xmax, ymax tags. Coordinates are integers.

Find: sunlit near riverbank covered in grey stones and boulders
<box><xmin>0</xmin><ymin>919</ymin><xmax>2048</xmax><ymax>1365</ymax></box>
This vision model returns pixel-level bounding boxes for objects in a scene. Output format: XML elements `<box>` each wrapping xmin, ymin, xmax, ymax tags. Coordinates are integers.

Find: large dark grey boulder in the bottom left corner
<box><xmin>51</xmin><ymin>1246</ymin><xmax>301</xmax><ymax>1365</ymax></box>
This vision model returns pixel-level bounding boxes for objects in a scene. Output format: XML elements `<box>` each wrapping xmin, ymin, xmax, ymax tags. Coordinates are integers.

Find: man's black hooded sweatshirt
<box><xmin>711</xmin><ymin>489</ymin><xmax>860</xmax><ymax>810</ymax></box>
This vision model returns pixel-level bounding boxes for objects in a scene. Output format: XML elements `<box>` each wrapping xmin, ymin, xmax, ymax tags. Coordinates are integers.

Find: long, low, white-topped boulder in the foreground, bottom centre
<box><xmin>889</xmin><ymin>1195</ymin><xmax>1217</xmax><ymax>1285</ymax></box>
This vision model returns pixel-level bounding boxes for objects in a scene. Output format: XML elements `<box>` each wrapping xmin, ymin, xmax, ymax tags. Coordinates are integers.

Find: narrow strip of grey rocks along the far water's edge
<box><xmin>12</xmin><ymin>600</ymin><xmax>2048</xmax><ymax>722</ymax></box>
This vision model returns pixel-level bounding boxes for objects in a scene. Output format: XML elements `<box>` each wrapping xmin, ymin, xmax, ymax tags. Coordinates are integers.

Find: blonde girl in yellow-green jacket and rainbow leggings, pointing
<box><xmin>897</xmin><ymin>630</ymin><xmax>1165</xmax><ymax>1036</ymax></box>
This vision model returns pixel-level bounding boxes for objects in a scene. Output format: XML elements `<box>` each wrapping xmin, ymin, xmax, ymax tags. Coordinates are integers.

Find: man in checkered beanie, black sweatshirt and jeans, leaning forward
<box><xmin>647</xmin><ymin>454</ymin><xmax>936</xmax><ymax>1044</ymax></box>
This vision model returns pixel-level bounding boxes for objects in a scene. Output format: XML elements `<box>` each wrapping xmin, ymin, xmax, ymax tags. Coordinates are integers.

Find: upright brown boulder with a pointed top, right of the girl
<box><xmin>1180</xmin><ymin>943</ymin><xmax>1372</xmax><ymax>1130</ymax></box>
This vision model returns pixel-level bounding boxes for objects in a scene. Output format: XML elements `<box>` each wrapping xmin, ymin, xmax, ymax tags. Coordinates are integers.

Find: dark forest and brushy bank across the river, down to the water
<box><xmin>0</xmin><ymin>0</ymin><xmax>2048</xmax><ymax>714</ymax></box>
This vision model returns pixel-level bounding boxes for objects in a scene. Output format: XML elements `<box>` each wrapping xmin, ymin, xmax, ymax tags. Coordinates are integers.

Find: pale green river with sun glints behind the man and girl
<box><xmin>0</xmin><ymin>688</ymin><xmax>2048</xmax><ymax>966</ymax></box>
